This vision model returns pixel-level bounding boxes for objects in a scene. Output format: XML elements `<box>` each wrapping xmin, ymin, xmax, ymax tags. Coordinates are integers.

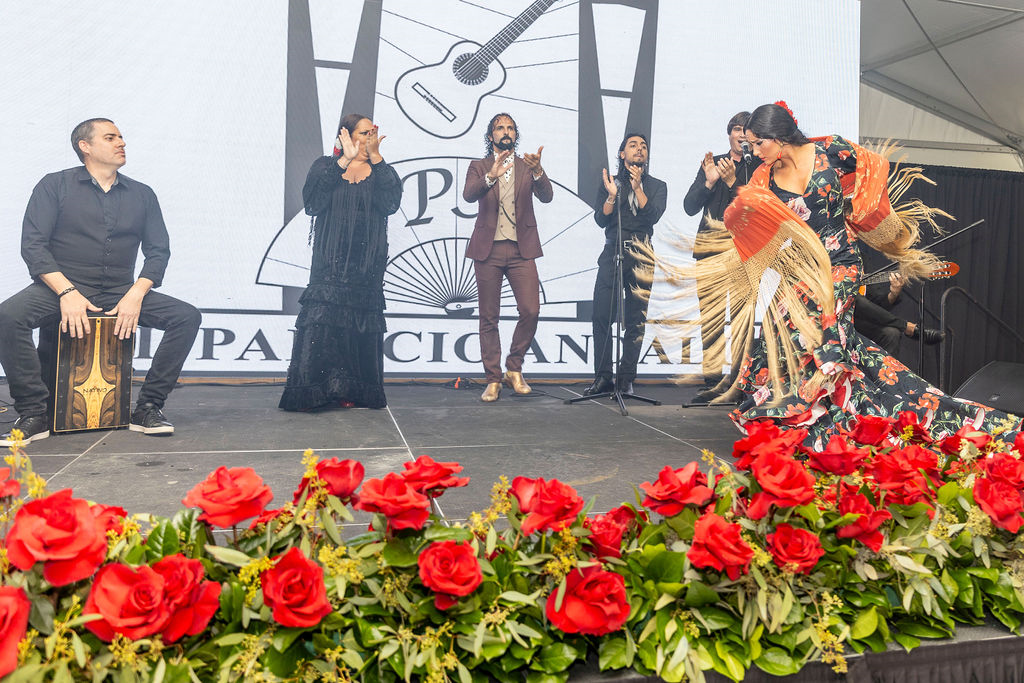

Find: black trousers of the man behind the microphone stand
<box><xmin>594</xmin><ymin>237</ymin><xmax>653</xmax><ymax>382</ymax></box>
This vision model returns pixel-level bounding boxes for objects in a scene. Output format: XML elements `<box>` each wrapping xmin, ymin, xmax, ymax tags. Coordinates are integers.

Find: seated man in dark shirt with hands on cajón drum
<box><xmin>0</xmin><ymin>119</ymin><xmax>202</xmax><ymax>446</ymax></box>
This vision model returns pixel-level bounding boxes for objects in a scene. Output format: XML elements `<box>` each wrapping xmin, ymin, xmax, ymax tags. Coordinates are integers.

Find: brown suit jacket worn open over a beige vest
<box><xmin>462</xmin><ymin>155</ymin><xmax>554</xmax><ymax>261</ymax></box>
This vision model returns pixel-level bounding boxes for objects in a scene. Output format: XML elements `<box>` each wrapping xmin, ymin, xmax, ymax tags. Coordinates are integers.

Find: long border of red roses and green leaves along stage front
<box><xmin>0</xmin><ymin>413</ymin><xmax>1024</xmax><ymax>683</ymax></box>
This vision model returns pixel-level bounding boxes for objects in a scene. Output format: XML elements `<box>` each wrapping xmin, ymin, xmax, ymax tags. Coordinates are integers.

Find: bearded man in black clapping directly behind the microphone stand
<box><xmin>584</xmin><ymin>133</ymin><xmax>669</xmax><ymax>396</ymax></box>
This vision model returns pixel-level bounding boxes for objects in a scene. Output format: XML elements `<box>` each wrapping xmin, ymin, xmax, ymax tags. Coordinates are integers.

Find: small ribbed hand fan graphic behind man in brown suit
<box><xmin>384</xmin><ymin>238</ymin><xmax>545</xmax><ymax>317</ymax></box>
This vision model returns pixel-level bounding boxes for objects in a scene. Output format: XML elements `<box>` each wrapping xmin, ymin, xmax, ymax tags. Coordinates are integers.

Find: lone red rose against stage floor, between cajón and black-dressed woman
<box><xmin>181</xmin><ymin>466</ymin><xmax>273</xmax><ymax>528</ymax></box>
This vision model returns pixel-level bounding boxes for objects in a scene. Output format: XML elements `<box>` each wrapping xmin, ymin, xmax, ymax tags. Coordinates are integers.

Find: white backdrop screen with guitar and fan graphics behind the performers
<box><xmin>0</xmin><ymin>0</ymin><xmax>860</xmax><ymax>376</ymax></box>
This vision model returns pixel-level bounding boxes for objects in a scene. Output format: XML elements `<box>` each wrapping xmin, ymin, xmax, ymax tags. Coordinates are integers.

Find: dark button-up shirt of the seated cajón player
<box><xmin>22</xmin><ymin>166</ymin><xmax>171</xmax><ymax>290</ymax></box>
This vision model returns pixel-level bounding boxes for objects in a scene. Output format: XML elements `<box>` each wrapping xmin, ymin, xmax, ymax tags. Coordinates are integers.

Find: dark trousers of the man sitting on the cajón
<box><xmin>0</xmin><ymin>283</ymin><xmax>203</xmax><ymax>417</ymax></box>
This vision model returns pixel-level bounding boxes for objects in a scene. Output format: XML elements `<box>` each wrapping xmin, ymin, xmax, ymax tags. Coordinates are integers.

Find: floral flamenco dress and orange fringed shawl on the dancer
<box><xmin>717</xmin><ymin>136</ymin><xmax>1021</xmax><ymax>450</ymax></box>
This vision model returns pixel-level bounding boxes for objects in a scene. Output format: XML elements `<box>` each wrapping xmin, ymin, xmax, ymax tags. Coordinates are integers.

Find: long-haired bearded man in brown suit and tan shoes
<box><xmin>462</xmin><ymin>114</ymin><xmax>553</xmax><ymax>402</ymax></box>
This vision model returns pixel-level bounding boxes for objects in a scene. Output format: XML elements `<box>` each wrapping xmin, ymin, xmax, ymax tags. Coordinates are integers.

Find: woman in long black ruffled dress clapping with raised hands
<box><xmin>280</xmin><ymin>114</ymin><xmax>401</xmax><ymax>411</ymax></box>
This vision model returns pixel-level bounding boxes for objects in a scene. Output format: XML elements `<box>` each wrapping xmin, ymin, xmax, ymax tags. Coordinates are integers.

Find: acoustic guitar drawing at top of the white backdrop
<box><xmin>394</xmin><ymin>0</ymin><xmax>557</xmax><ymax>138</ymax></box>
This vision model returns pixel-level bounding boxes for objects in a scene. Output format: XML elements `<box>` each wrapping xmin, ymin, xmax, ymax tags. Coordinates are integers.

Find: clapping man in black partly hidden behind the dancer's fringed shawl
<box><xmin>683</xmin><ymin>112</ymin><xmax>761</xmax><ymax>405</ymax></box>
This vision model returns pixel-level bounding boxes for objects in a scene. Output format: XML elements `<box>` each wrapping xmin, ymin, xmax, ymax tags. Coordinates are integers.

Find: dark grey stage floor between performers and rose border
<box><xmin>0</xmin><ymin>383</ymin><xmax>740</xmax><ymax>519</ymax></box>
